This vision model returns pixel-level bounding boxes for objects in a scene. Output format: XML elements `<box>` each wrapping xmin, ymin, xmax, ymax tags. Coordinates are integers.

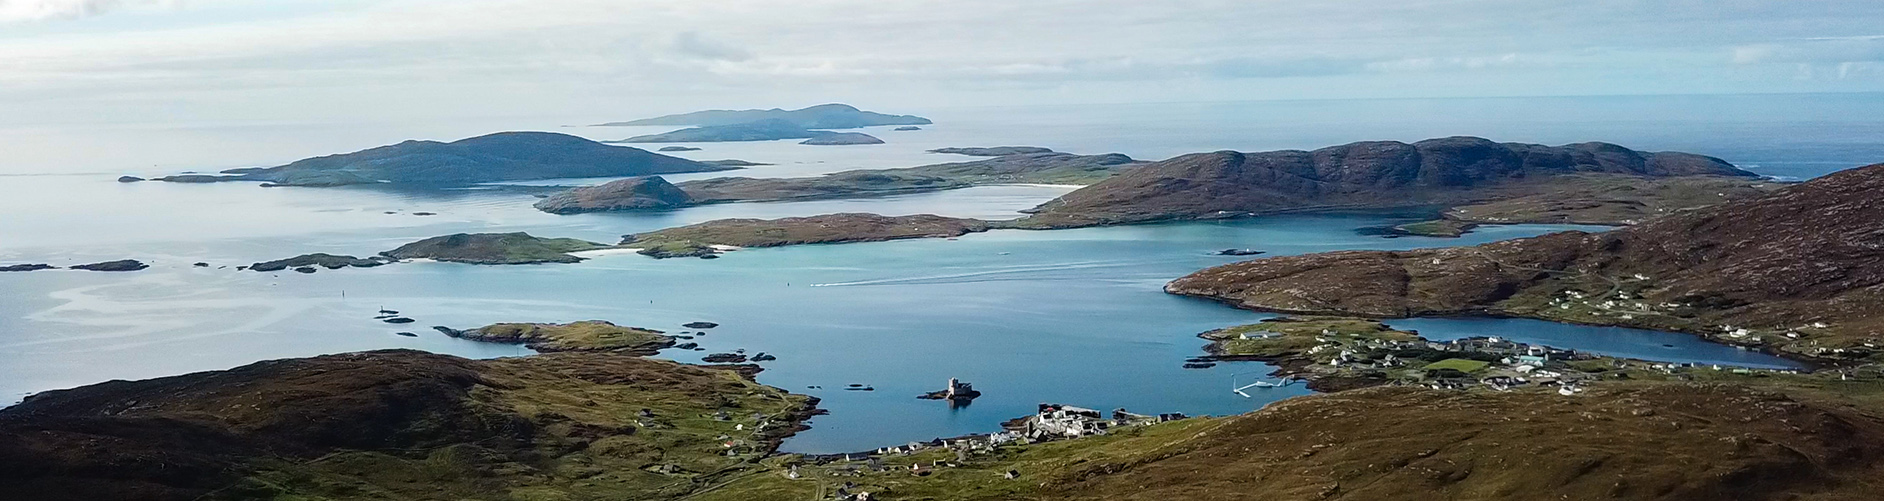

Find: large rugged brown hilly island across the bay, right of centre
<box><xmin>1027</xmin><ymin>137</ymin><xmax>1773</xmax><ymax>228</ymax></box>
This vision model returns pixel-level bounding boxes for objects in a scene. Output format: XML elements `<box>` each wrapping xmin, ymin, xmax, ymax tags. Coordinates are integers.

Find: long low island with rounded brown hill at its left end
<box><xmin>537</xmin><ymin>153</ymin><xmax>1144</xmax><ymax>215</ymax></box>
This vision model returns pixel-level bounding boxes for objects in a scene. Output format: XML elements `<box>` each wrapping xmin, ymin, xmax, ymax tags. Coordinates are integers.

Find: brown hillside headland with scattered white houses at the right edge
<box><xmin>1164</xmin><ymin>164</ymin><xmax>1884</xmax><ymax>360</ymax></box>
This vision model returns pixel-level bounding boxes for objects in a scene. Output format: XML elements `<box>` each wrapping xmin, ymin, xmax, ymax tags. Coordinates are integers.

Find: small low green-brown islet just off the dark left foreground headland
<box><xmin>433</xmin><ymin>320</ymin><xmax>674</xmax><ymax>356</ymax></box>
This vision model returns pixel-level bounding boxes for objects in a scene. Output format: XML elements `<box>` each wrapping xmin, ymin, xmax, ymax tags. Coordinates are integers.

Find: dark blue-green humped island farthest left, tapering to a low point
<box><xmin>154</xmin><ymin>132</ymin><xmax>735</xmax><ymax>186</ymax></box>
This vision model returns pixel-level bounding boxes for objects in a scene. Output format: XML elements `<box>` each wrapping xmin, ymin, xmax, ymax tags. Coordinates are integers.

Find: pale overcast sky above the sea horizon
<box><xmin>0</xmin><ymin>0</ymin><xmax>1884</xmax><ymax>124</ymax></box>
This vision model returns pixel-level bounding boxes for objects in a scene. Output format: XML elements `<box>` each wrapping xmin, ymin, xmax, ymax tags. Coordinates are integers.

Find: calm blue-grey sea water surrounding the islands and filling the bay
<box><xmin>0</xmin><ymin>96</ymin><xmax>1861</xmax><ymax>452</ymax></box>
